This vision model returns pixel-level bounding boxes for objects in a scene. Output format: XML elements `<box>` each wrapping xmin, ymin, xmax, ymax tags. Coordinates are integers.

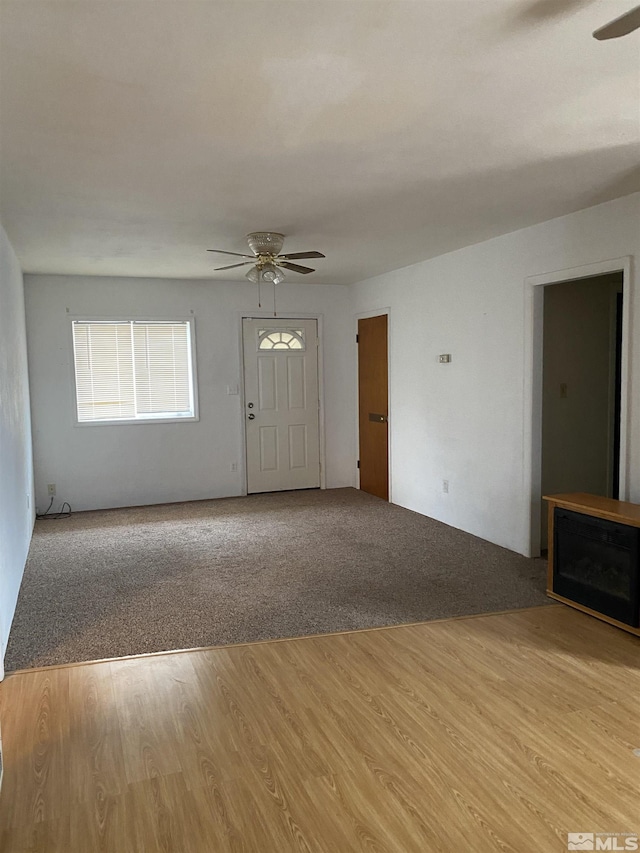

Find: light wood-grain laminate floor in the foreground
<box><xmin>0</xmin><ymin>605</ymin><xmax>640</xmax><ymax>853</ymax></box>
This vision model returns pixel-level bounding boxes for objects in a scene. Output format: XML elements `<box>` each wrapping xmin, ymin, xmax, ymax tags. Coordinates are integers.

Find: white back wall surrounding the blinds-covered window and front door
<box><xmin>25</xmin><ymin>275</ymin><xmax>355</xmax><ymax>510</ymax></box>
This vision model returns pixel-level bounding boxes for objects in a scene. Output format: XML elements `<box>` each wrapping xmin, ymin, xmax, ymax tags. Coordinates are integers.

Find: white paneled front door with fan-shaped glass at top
<box><xmin>242</xmin><ymin>318</ymin><xmax>320</xmax><ymax>494</ymax></box>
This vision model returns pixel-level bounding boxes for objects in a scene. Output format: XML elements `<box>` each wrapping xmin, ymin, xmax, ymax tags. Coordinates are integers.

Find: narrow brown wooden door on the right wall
<box><xmin>358</xmin><ymin>314</ymin><xmax>389</xmax><ymax>500</ymax></box>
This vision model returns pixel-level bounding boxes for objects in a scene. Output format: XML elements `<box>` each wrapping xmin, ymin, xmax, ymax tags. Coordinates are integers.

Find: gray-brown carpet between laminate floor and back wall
<box><xmin>5</xmin><ymin>489</ymin><xmax>549</xmax><ymax>670</ymax></box>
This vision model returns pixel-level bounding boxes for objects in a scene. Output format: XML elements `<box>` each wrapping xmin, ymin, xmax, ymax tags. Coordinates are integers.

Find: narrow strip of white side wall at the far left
<box><xmin>0</xmin><ymin>227</ymin><xmax>34</xmax><ymax>677</ymax></box>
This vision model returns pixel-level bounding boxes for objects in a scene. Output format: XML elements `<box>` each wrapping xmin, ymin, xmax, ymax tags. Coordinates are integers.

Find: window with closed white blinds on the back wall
<box><xmin>73</xmin><ymin>320</ymin><xmax>196</xmax><ymax>423</ymax></box>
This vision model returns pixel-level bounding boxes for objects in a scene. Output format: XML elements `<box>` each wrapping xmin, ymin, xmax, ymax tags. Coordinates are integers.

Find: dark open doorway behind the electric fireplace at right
<box><xmin>539</xmin><ymin>271</ymin><xmax>623</xmax><ymax>554</ymax></box>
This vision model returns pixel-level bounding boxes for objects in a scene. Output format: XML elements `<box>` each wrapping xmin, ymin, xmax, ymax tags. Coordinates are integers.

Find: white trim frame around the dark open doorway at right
<box><xmin>523</xmin><ymin>255</ymin><xmax>631</xmax><ymax>557</ymax></box>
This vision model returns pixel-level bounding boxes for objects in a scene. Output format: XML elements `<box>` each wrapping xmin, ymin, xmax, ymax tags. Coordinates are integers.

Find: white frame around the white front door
<box><xmin>237</xmin><ymin>310</ymin><xmax>327</xmax><ymax>495</ymax></box>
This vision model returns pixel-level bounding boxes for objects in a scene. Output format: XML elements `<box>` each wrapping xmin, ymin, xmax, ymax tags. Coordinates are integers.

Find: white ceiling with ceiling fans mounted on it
<box><xmin>0</xmin><ymin>0</ymin><xmax>640</xmax><ymax>284</ymax></box>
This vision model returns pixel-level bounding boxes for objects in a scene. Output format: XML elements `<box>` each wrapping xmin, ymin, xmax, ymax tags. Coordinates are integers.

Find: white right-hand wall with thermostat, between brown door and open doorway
<box><xmin>353</xmin><ymin>193</ymin><xmax>640</xmax><ymax>553</ymax></box>
